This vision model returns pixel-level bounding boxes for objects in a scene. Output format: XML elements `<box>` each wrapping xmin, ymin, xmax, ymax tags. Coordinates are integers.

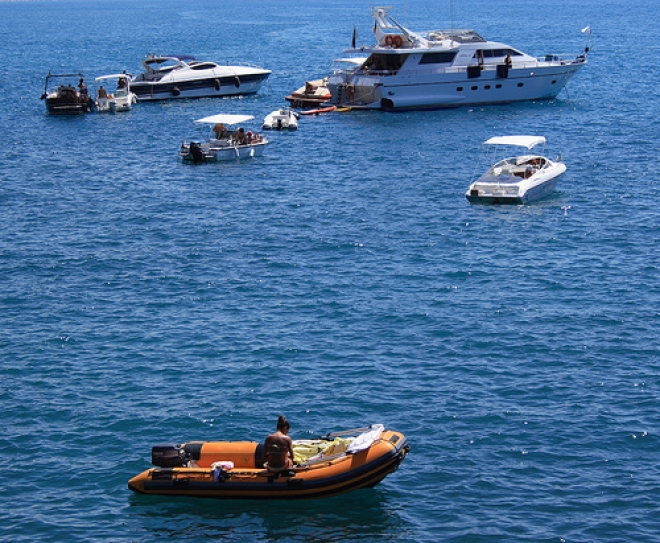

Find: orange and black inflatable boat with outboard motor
<box><xmin>128</xmin><ymin>424</ymin><xmax>410</xmax><ymax>499</ymax></box>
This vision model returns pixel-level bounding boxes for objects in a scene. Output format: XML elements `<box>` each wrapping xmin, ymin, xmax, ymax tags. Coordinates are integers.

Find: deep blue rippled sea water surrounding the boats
<box><xmin>0</xmin><ymin>0</ymin><xmax>660</xmax><ymax>542</ymax></box>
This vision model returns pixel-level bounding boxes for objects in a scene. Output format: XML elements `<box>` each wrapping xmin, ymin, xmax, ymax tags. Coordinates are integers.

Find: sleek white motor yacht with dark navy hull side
<box><xmin>131</xmin><ymin>56</ymin><xmax>271</xmax><ymax>100</ymax></box>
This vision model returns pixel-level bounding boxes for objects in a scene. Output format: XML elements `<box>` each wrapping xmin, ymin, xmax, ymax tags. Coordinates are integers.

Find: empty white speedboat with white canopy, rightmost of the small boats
<box><xmin>465</xmin><ymin>136</ymin><xmax>566</xmax><ymax>204</ymax></box>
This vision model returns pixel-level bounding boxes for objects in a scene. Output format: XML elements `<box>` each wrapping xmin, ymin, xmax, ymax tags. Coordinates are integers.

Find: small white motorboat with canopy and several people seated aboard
<box><xmin>179</xmin><ymin>115</ymin><xmax>268</xmax><ymax>164</ymax></box>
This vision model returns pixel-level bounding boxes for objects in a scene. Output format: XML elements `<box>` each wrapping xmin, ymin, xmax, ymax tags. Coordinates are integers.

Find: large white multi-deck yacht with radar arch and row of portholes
<box><xmin>328</xmin><ymin>7</ymin><xmax>589</xmax><ymax>110</ymax></box>
